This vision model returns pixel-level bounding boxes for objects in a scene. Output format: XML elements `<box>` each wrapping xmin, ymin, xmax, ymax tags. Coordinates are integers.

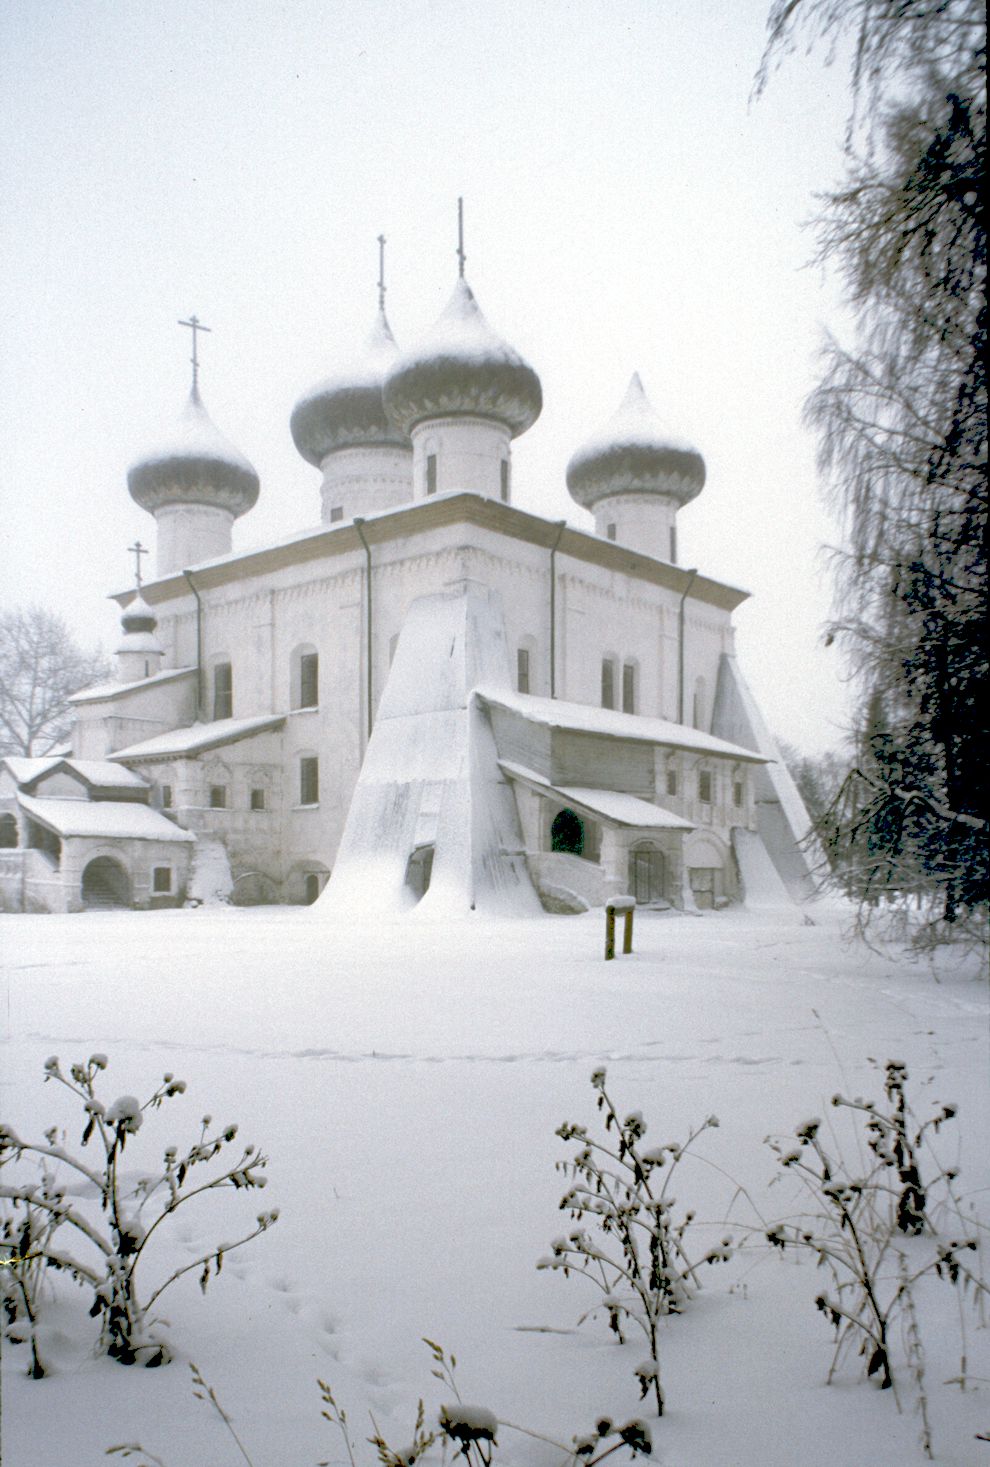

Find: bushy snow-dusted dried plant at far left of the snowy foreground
<box><xmin>0</xmin><ymin>1055</ymin><xmax>279</xmax><ymax>1373</ymax></box>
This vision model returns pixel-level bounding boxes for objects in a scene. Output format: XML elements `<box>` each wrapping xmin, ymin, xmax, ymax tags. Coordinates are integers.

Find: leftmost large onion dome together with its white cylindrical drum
<box><xmin>128</xmin><ymin>387</ymin><xmax>258</xmax><ymax>575</ymax></box>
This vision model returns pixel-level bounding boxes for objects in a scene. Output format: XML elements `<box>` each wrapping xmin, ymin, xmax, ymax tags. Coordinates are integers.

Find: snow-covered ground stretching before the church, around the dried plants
<box><xmin>0</xmin><ymin>908</ymin><xmax>990</xmax><ymax>1467</ymax></box>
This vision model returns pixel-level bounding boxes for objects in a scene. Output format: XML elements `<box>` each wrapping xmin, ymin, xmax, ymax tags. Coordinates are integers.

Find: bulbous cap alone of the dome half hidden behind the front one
<box><xmin>289</xmin><ymin>310</ymin><xmax>409</xmax><ymax>468</ymax></box>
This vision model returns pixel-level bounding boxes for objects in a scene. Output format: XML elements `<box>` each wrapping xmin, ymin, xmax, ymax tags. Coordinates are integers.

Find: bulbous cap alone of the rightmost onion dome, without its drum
<box><xmin>568</xmin><ymin>373</ymin><xmax>704</xmax><ymax>509</ymax></box>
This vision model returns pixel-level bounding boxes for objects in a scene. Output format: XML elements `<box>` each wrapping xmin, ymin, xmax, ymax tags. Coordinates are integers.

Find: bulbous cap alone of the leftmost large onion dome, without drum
<box><xmin>128</xmin><ymin>386</ymin><xmax>258</xmax><ymax>518</ymax></box>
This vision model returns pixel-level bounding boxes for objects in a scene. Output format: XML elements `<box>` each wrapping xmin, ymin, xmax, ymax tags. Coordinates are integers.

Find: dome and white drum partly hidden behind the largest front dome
<box><xmin>289</xmin><ymin>307</ymin><xmax>412</xmax><ymax>521</ymax></box>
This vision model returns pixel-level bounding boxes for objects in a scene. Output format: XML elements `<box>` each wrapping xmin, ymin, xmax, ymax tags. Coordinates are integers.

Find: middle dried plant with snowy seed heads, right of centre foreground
<box><xmin>537</xmin><ymin>1069</ymin><xmax>732</xmax><ymax>1416</ymax></box>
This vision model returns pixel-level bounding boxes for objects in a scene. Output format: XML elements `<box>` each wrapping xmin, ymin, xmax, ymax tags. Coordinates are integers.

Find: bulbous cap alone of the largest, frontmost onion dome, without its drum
<box><xmin>384</xmin><ymin>276</ymin><xmax>543</xmax><ymax>439</ymax></box>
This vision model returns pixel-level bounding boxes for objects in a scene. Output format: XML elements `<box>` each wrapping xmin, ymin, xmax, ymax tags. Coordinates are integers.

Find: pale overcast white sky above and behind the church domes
<box><xmin>0</xmin><ymin>0</ymin><xmax>846</xmax><ymax>751</ymax></box>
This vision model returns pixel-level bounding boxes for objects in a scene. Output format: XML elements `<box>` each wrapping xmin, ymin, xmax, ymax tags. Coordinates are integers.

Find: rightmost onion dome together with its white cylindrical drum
<box><xmin>568</xmin><ymin>373</ymin><xmax>705</xmax><ymax>560</ymax></box>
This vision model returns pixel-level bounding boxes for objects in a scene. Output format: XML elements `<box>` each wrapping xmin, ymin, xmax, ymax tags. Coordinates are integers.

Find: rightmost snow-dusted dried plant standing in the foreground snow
<box><xmin>767</xmin><ymin>1061</ymin><xmax>990</xmax><ymax>1455</ymax></box>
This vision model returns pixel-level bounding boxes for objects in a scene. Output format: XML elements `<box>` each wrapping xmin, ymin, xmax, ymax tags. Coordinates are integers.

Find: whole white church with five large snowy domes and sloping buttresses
<box><xmin>0</xmin><ymin>247</ymin><xmax>813</xmax><ymax>914</ymax></box>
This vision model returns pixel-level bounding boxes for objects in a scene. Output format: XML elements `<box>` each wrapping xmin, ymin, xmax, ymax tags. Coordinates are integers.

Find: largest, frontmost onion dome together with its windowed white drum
<box><xmin>384</xmin><ymin>276</ymin><xmax>543</xmax><ymax>500</ymax></box>
